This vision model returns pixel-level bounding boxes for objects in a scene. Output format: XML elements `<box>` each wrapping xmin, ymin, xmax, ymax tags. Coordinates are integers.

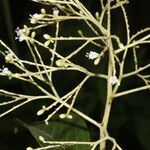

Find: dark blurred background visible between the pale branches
<box><xmin>0</xmin><ymin>0</ymin><xmax>150</xmax><ymax>150</ymax></box>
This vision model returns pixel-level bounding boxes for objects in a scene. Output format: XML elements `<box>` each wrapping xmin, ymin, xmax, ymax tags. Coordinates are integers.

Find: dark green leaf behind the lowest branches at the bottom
<box><xmin>19</xmin><ymin>114</ymin><xmax>90</xmax><ymax>150</ymax></box>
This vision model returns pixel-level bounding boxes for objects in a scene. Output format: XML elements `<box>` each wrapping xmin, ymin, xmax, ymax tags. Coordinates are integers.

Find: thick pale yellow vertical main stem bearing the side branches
<box><xmin>100</xmin><ymin>0</ymin><xmax>115</xmax><ymax>150</ymax></box>
